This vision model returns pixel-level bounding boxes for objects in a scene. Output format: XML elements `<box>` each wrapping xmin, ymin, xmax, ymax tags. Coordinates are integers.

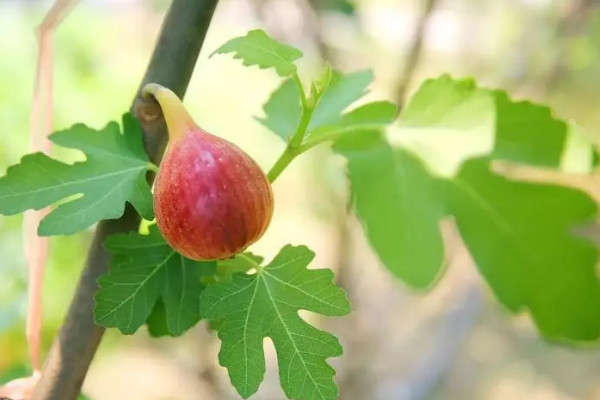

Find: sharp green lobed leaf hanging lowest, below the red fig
<box><xmin>200</xmin><ymin>245</ymin><xmax>350</xmax><ymax>400</ymax></box>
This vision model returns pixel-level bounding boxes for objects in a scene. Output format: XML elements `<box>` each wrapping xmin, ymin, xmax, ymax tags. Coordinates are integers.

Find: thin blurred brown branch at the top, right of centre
<box><xmin>396</xmin><ymin>0</ymin><xmax>438</xmax><ymax>109</ymax></box>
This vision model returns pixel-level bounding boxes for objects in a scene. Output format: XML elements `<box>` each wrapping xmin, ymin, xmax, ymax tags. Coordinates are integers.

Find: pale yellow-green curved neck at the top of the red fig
<box><xmin>142</xmin><ymin>83</ymin><xmax>196</xmax><ymax>144</ymax></box>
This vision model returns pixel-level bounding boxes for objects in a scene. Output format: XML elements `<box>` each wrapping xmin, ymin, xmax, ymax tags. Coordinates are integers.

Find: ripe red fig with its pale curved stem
<box><xmin>143</xmin><ymin>84</ymin><xmax>273</xmax><ymax>260</ymax></box>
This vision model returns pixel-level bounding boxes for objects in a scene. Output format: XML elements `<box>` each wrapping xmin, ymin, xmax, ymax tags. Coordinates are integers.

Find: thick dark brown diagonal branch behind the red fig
<box><xmin>33</xmin><ymin>0</ymin><xmax>218</xmax><ymax>400</ymax></box>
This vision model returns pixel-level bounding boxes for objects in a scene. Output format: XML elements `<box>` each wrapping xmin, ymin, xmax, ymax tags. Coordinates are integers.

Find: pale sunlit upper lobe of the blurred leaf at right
<box><xmin>389</xmin><ymin>75</ymin><xmax>496</xmax><ymax>177</ymax></box>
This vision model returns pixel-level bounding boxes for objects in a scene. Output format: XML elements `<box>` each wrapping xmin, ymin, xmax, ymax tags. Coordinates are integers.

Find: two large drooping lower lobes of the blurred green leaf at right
<box><xmin>334</xmin><ymin>126</ymin><xmax>600</xmax><ymax>340</ymax></box>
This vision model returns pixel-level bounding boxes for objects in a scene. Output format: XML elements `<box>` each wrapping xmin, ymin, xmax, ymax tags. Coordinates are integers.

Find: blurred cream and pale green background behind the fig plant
<box><xmin>0</xmin><ymin>0</ymin><xmax>600</xmax><ymax>400</ymax></box>
